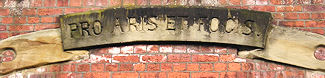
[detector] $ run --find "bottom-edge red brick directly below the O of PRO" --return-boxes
[83,72,111,78]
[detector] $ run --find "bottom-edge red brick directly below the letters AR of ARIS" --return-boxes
[112,72,139,78]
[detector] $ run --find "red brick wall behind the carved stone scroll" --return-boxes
[0,0,325,78]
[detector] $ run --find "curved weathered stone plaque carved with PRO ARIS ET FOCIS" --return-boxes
[60,7,271,49]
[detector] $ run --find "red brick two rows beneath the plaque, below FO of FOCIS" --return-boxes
[192,54,219,62]
